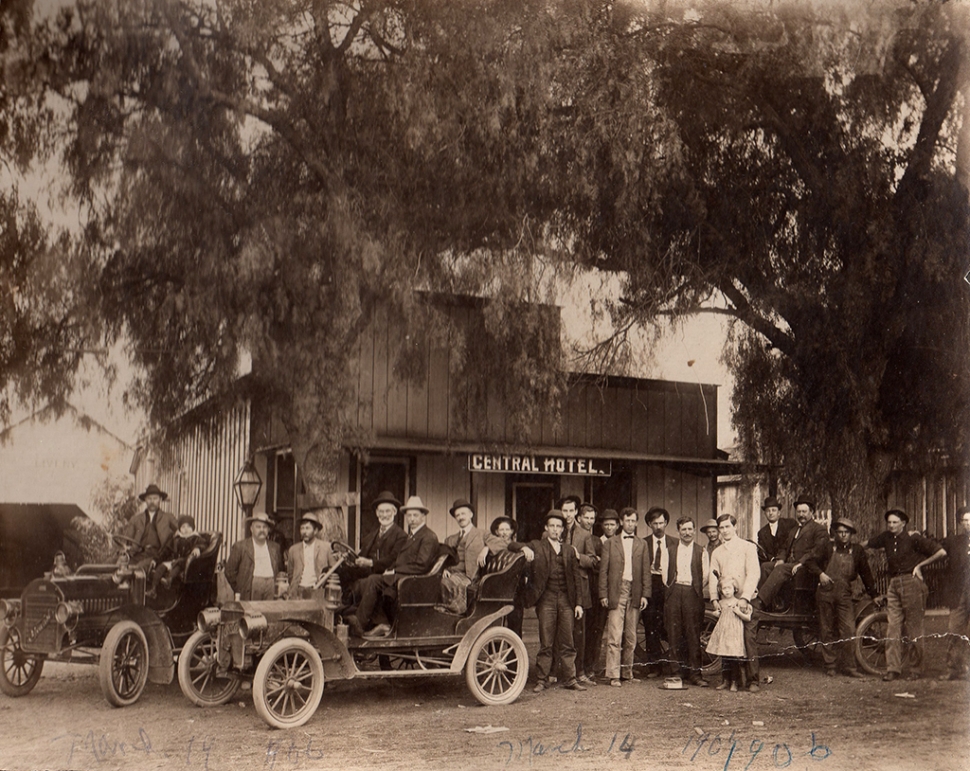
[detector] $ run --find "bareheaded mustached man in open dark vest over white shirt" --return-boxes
[664,517,711,687]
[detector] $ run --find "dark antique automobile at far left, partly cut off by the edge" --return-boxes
[0,533,225,707]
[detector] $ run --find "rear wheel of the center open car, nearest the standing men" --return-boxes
[465,626,529,706]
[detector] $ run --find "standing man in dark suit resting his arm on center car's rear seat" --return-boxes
[509,509,586,693]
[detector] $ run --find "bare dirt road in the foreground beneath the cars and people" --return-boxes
[0,619,970,771]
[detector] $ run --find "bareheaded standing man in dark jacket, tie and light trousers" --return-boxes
[599,507,651,688]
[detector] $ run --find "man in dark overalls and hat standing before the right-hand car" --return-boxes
[815,517,879,677]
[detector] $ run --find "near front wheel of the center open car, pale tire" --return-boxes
[253,637,323,728]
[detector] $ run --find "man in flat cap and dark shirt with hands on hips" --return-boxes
[866,509,946,681]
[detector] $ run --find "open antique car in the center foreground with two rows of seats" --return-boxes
[178,543,529,728]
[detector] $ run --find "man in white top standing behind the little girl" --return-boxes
[708,514,761,693]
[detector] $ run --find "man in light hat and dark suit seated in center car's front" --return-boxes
[347,495,438,637]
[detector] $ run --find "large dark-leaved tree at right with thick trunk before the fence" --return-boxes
[552,3,970,520]
